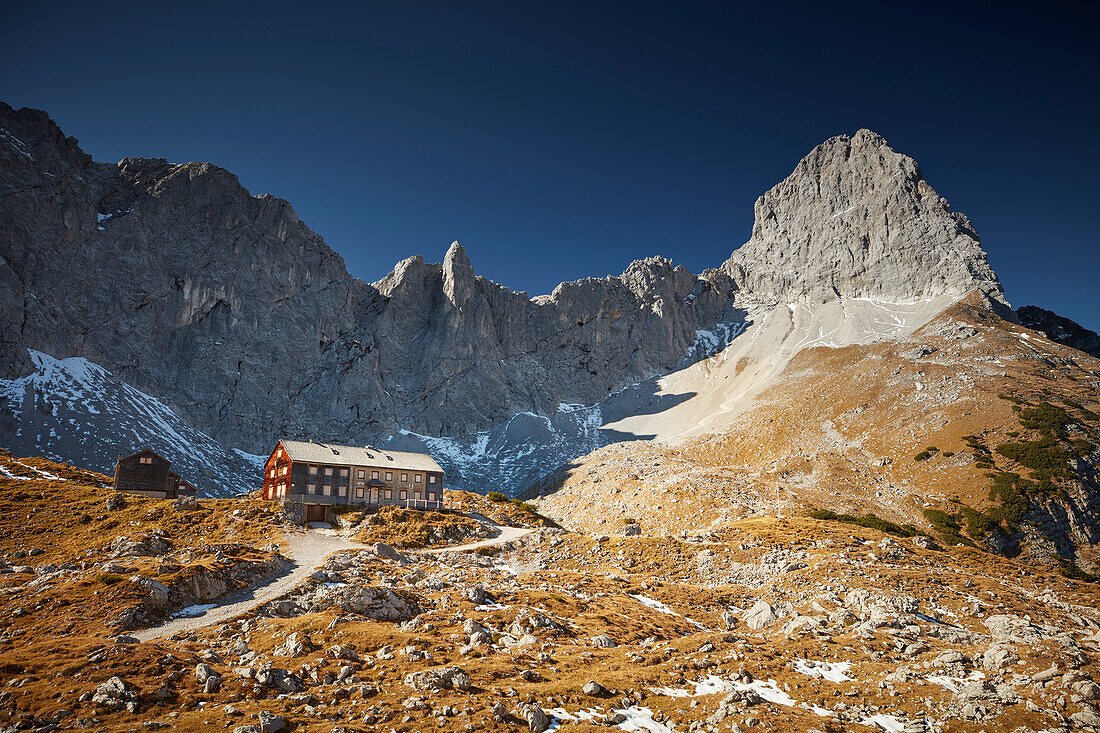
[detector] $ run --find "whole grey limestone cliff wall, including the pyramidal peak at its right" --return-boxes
[0,103,1000,462]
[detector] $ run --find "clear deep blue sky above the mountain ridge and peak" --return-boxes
[0,0,1100,330]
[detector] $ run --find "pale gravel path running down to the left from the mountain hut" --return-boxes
[130,529,363,642]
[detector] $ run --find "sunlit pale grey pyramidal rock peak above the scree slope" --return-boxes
[724,130,1003,303]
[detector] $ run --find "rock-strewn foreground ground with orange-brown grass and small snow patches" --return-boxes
[0,449,1100,733]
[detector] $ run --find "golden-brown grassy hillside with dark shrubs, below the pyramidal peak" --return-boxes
[531,293,1100,573]
